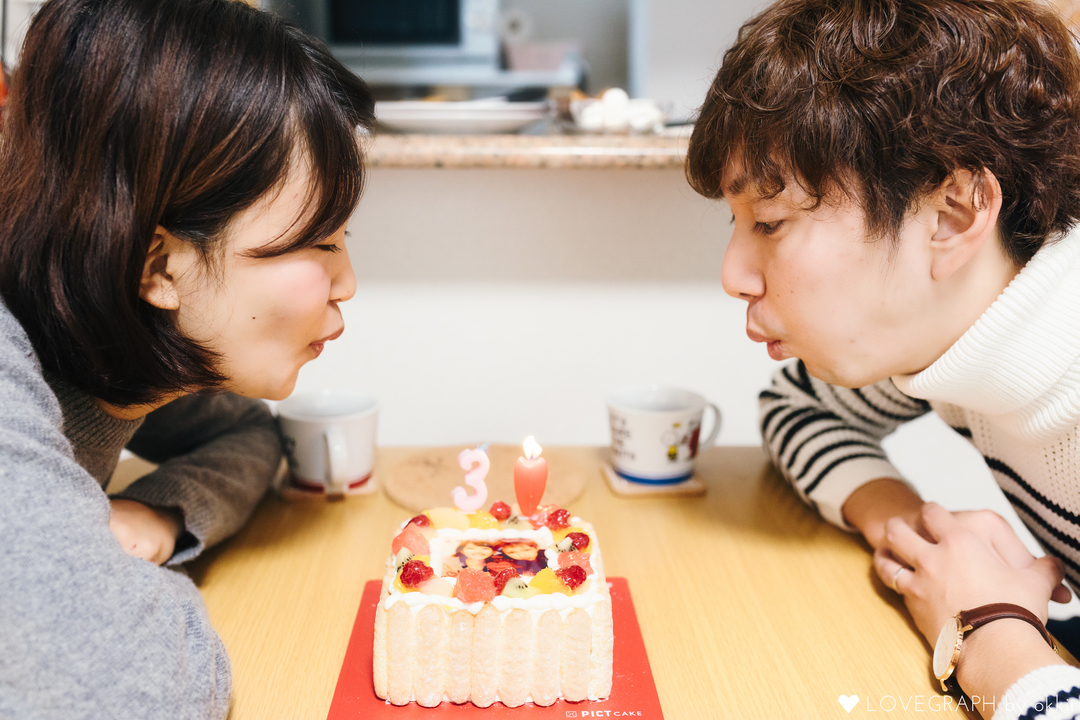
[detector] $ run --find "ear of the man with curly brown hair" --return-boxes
[930,168,1001,281]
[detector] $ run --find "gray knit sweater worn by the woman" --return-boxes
[0,304,281,720]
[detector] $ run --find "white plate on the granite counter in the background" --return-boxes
[375,100,548,135]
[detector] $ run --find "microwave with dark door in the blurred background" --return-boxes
[319,0,499,68]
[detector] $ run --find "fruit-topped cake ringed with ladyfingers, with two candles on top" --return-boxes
[374,437,612,707]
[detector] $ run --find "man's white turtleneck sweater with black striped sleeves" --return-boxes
[760,230,1080,720]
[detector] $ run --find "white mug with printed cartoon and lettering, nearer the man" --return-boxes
[608,385,720,485]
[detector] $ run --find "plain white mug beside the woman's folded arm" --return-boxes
[278,389,379,494]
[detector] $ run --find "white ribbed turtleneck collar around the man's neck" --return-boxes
[893,229,1080,439]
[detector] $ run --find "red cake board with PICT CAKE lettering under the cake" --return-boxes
[326,578,664,720]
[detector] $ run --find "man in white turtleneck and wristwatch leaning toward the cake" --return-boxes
[687,0,1080,718]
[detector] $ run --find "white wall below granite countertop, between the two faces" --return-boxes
[291,169,743,445]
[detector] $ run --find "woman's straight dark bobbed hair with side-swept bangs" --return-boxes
[0,0,374,405]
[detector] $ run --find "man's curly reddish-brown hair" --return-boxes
[686,0,1080,264]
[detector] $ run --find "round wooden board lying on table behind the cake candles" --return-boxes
[383,445,596,513]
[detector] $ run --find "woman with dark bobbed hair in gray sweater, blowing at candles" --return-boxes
[0,0,374,719]
